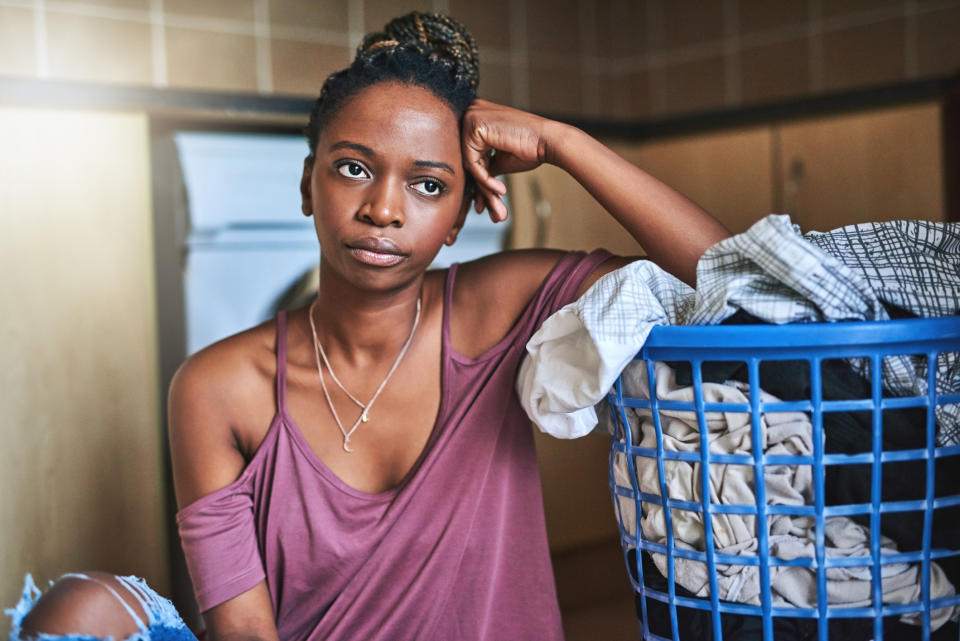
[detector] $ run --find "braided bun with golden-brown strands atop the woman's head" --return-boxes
[357,11,480,92]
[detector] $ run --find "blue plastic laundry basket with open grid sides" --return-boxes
[608,317,960,641]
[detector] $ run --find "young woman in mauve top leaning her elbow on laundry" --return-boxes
[11,13,727,641]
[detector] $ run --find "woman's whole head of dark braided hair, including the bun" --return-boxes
[304,11,480,160]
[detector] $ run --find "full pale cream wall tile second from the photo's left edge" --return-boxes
[47,11,153,84]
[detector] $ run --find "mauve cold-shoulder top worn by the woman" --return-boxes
[177,251,609,641]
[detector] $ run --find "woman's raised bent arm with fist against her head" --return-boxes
[462,100,730,285]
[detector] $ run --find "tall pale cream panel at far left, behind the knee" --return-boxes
[0,107,169,636]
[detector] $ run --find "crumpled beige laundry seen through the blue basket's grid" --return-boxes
[614,362,960,629]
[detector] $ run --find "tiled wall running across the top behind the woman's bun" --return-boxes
[0,0,960,120]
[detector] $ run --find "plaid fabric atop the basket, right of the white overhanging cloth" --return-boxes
[683,215,960,445]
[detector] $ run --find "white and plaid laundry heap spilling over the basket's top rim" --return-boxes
[517,215,960,446]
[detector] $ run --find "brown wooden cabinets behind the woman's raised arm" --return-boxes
[510,102,948,254]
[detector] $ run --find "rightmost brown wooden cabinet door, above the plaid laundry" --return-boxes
[777,104,944,231]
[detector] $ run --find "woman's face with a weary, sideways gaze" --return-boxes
[301,82,470,289]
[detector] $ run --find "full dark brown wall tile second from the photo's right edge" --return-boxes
[823,18,905,91]
